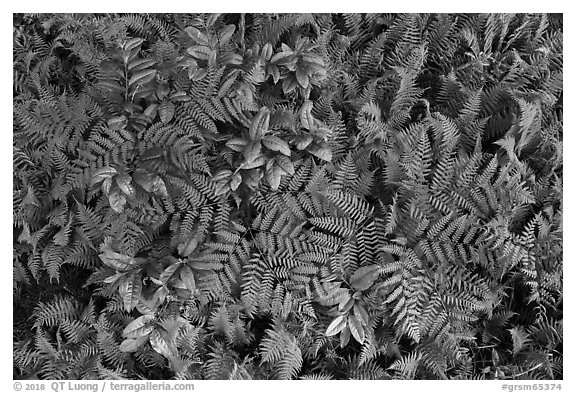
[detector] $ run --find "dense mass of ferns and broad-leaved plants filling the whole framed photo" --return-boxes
[13,14,563,379]
